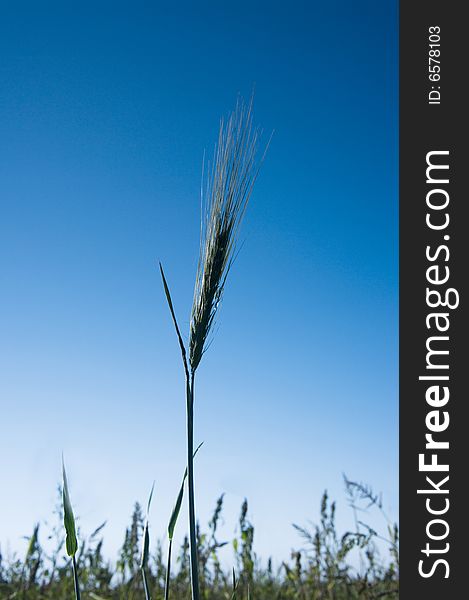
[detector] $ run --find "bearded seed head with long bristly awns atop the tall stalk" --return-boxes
[189,100,261,373]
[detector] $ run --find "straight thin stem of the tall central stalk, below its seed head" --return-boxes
[186,373,199,600]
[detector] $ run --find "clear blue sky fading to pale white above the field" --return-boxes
[0,0,398,558]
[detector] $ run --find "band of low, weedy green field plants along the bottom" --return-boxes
[0,479,399,600]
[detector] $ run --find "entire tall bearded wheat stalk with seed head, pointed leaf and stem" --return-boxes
[160,98,265,600]
